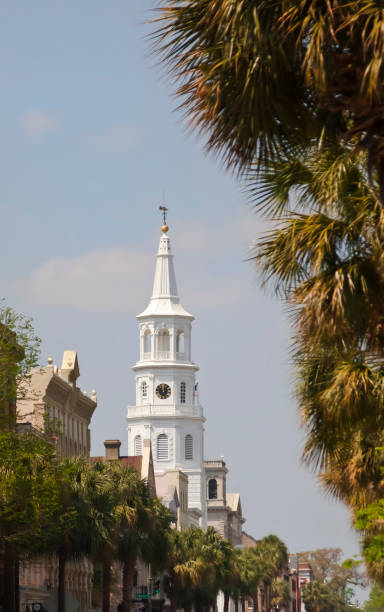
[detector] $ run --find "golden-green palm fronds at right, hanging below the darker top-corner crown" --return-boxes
[252,146,384,504]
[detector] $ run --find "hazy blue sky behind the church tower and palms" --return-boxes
[0,0,364,584]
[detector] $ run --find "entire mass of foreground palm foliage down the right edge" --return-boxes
[153,0,384,584]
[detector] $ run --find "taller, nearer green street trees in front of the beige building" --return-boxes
[0,432,172,612]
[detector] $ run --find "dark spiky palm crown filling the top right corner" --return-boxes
[153,0,384,196]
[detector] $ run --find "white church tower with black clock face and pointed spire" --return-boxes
[127,219,207,527]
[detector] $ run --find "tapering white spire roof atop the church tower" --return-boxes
[137,233,194,319]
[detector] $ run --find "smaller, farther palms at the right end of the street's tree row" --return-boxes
[165,527,290,612]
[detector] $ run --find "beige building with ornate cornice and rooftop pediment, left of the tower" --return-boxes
[17,351,97,612]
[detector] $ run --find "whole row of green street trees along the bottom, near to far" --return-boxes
[0,432,289,612]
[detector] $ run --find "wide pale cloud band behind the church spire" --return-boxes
[14,216,264,316]
